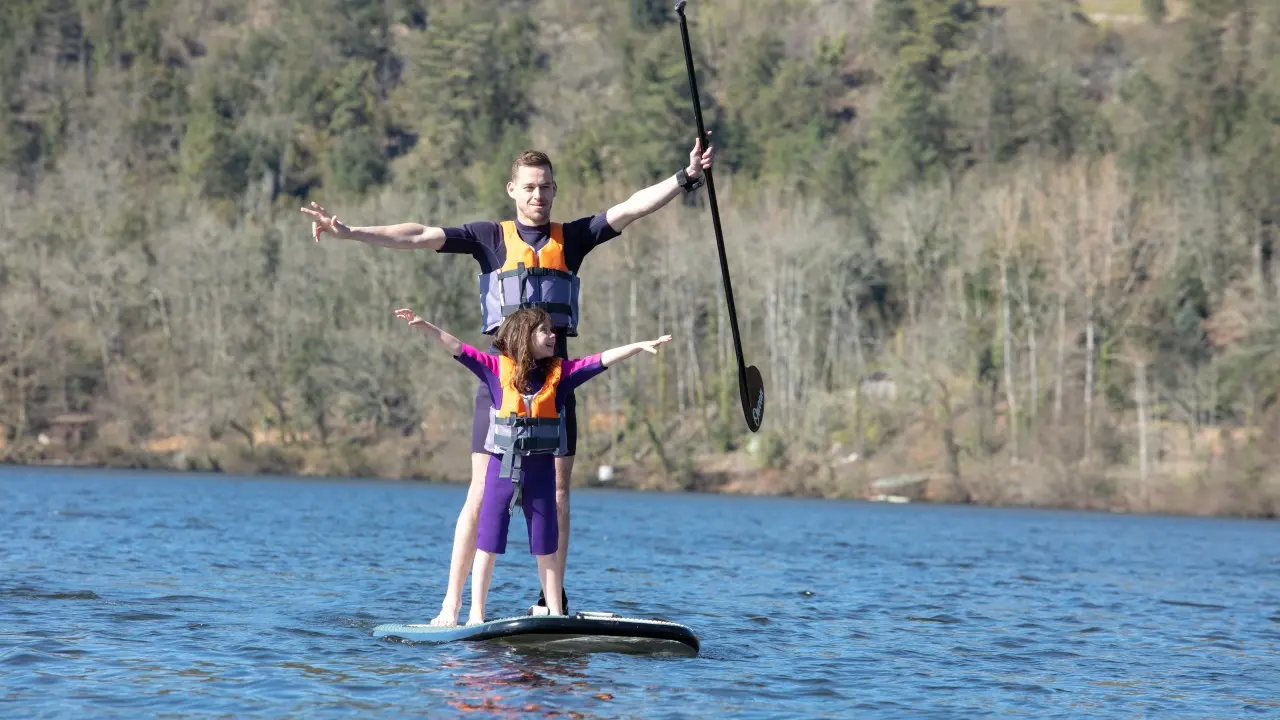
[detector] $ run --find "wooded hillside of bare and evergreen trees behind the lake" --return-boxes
[0,0,1280,515]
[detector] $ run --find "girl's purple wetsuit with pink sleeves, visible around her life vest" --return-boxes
[456,342,605,555]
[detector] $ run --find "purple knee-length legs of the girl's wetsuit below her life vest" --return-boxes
[476,455,559,555]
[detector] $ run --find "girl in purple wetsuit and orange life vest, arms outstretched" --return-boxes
[396,302,671,625]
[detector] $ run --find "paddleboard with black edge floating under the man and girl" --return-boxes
[374,611,699,655]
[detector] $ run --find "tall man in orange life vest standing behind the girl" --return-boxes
[302,134,714,625]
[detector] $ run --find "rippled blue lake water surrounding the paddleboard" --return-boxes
[0,468,1280,719]
